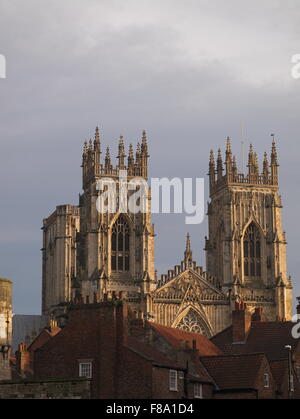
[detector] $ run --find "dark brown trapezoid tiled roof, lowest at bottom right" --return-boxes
[200,354,265,390]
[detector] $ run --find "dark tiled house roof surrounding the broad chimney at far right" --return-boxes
[211,322,299,361]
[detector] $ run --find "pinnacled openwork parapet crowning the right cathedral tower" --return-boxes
[208,137,279,195]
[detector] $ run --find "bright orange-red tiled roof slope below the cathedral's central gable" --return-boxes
[150,323,223,356]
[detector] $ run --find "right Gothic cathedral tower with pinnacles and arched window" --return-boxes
[205,138,292,320]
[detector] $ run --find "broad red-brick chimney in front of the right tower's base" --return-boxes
[232,302,251,343]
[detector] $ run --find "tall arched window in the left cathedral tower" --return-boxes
[111,215,130,272]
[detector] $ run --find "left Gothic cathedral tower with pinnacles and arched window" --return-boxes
[73,128,155,316]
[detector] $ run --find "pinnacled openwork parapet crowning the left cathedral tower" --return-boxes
[82,127,149,189]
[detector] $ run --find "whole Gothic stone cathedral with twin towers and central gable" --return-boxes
[42,128,292,338]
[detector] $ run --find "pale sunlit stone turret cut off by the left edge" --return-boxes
[0,278,12,380]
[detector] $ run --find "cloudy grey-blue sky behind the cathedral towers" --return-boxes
[0,0,300,314]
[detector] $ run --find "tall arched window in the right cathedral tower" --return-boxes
[244,223,261,278]
